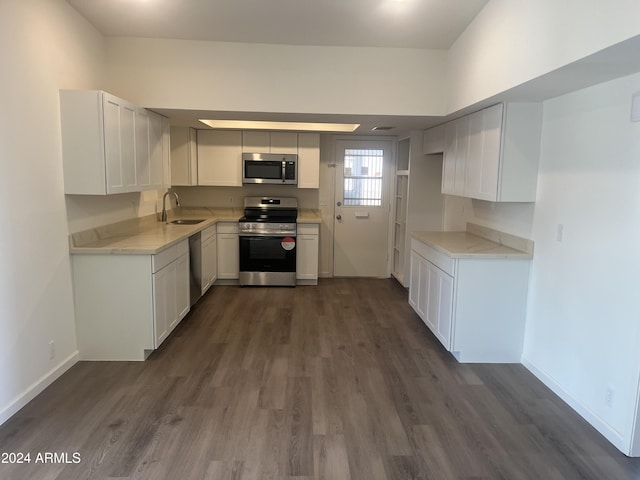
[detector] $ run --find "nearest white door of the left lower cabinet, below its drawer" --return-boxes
[153,262,177,348]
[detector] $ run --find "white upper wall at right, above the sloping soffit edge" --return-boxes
[447,0,640,112]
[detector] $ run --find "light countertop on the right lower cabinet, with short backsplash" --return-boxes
[412,223,533,259]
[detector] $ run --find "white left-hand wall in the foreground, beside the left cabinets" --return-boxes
[0,0,103,422]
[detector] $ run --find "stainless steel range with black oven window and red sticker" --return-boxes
[238,197,298,286]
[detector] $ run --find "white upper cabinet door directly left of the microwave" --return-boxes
[198,130,242,187]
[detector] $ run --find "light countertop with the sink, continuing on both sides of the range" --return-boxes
[69,208,321,255]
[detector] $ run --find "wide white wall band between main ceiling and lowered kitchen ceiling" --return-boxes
[107,38,446,115]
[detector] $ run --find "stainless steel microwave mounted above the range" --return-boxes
[242,153,298,185]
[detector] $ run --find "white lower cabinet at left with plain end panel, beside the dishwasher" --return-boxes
[71,240,190,360]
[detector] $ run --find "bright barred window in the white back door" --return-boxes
[343,148,384,206]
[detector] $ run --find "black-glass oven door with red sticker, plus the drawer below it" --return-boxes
[240,235,297,285]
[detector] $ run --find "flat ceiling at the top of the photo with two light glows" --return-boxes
[67,0,488,49]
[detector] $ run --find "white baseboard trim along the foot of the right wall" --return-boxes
[522,355,631,456]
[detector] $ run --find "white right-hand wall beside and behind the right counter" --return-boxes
[445,74,640,455]
